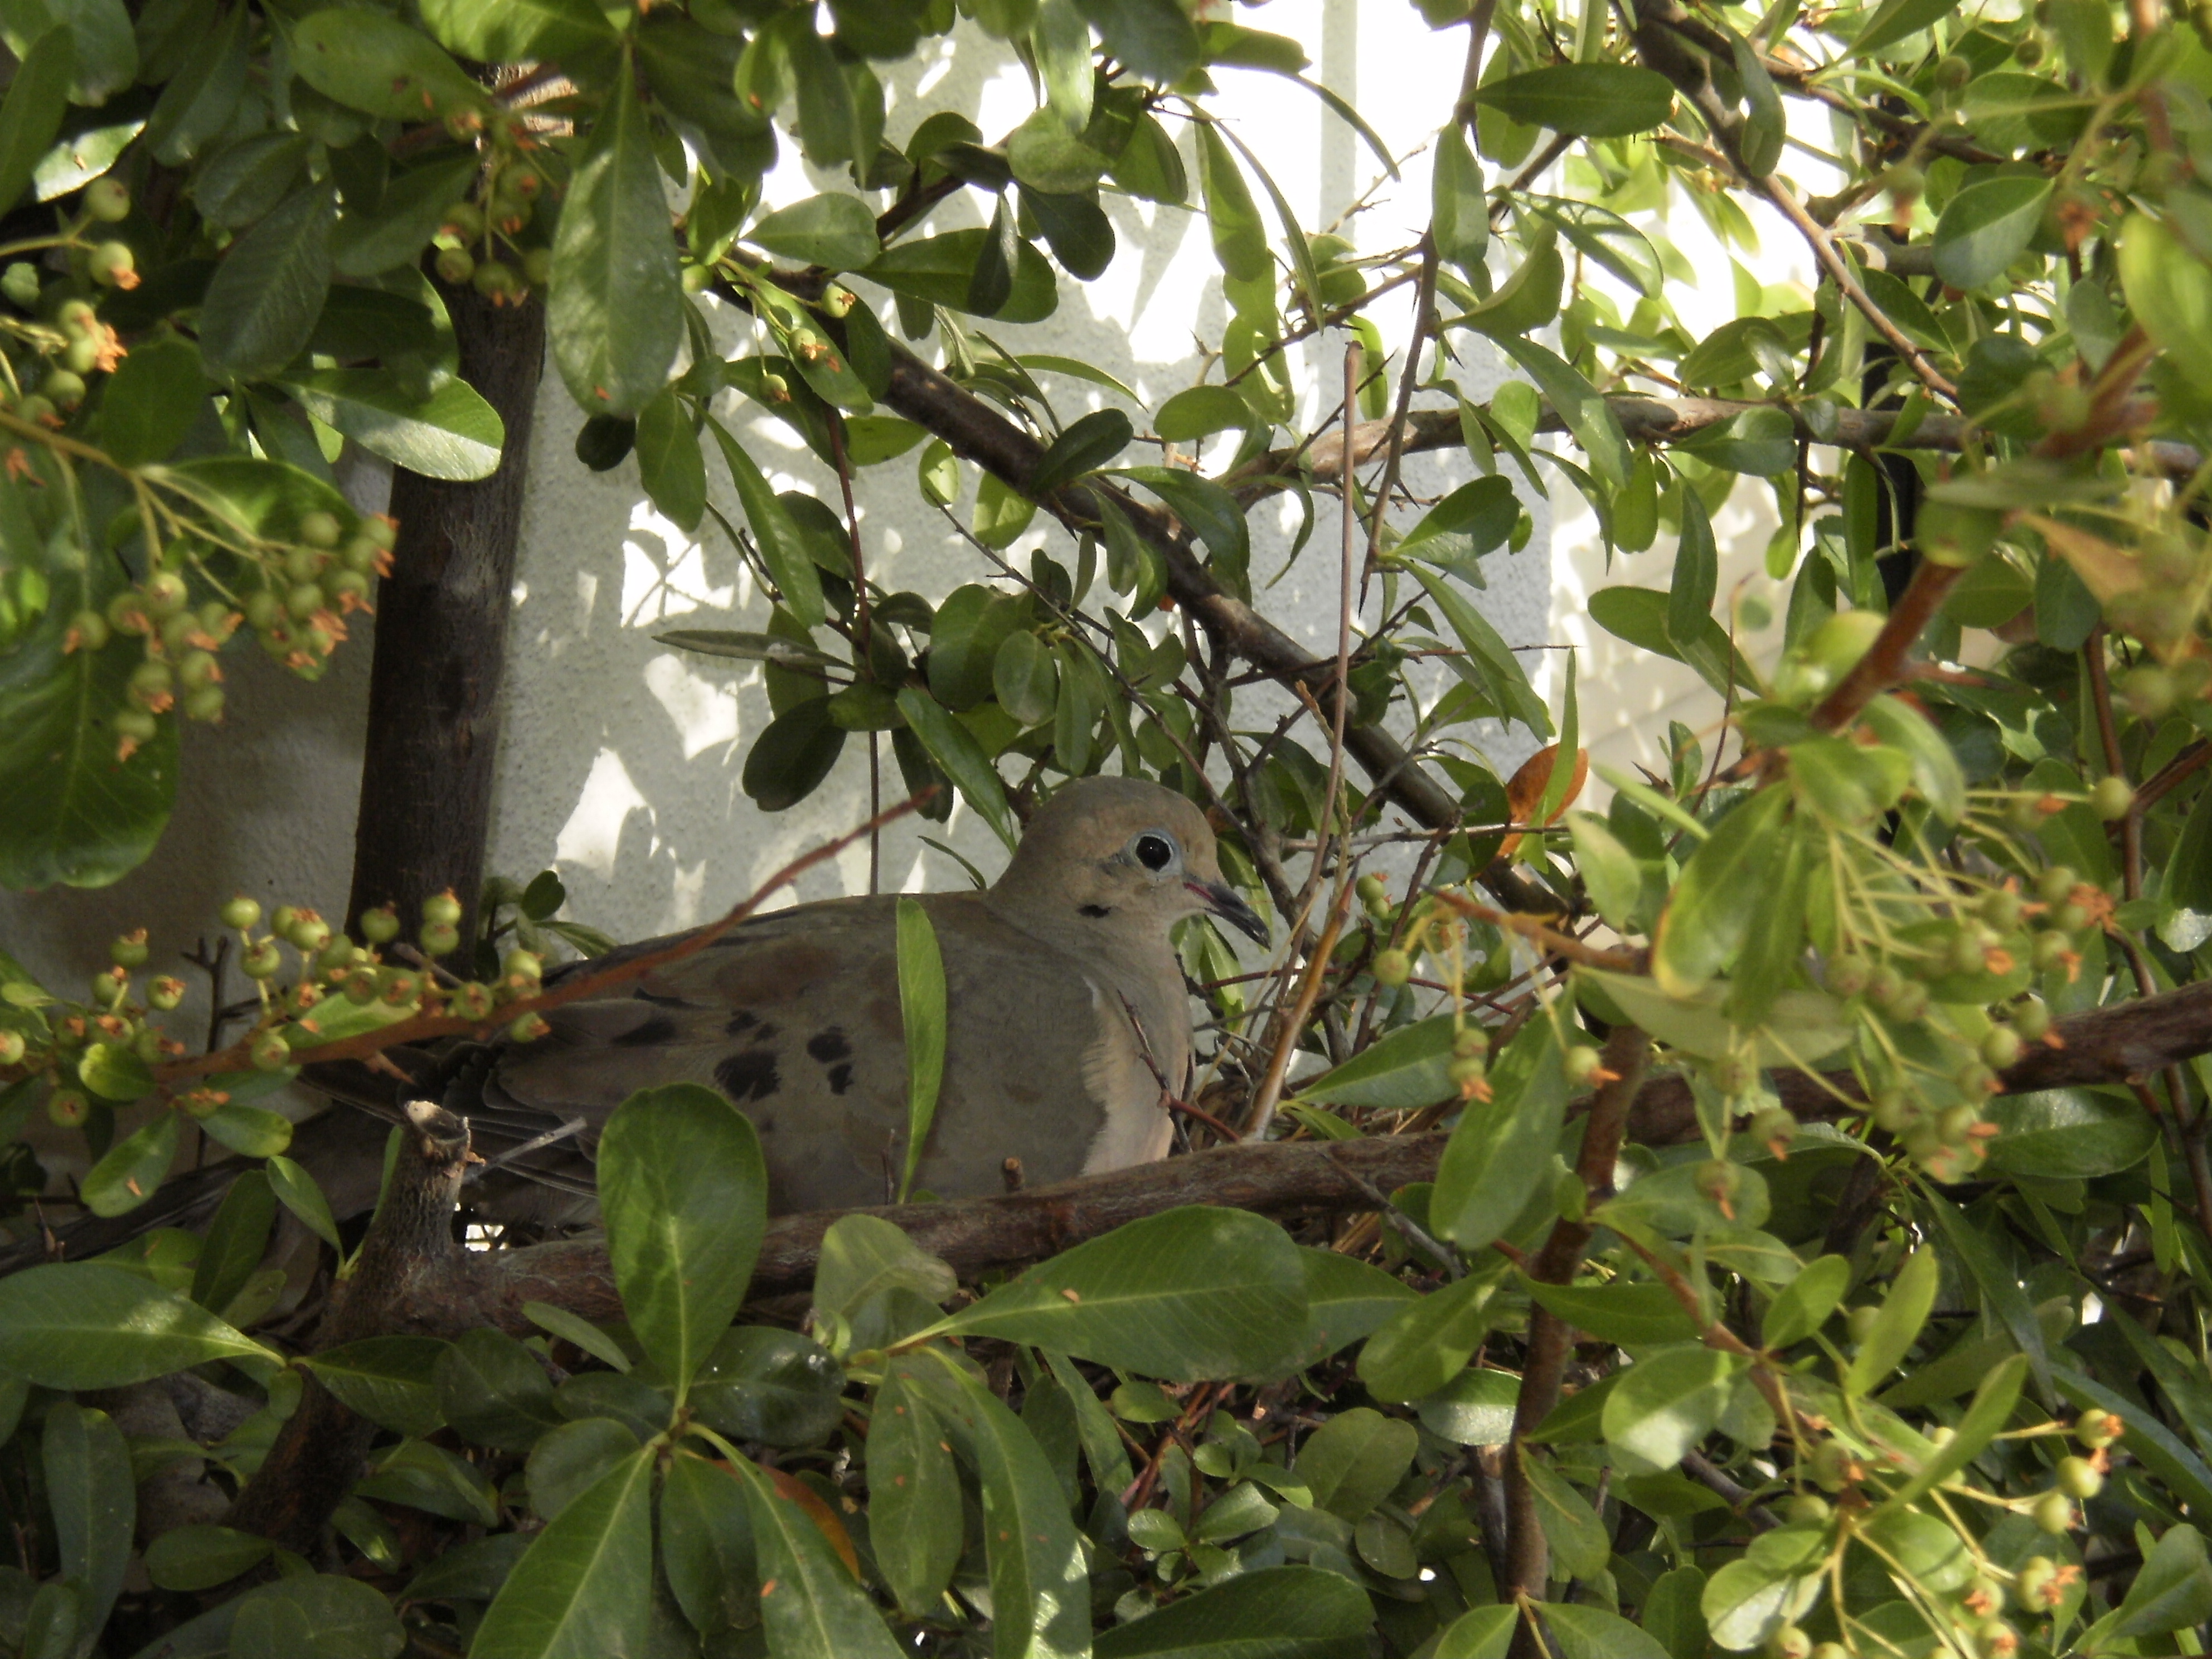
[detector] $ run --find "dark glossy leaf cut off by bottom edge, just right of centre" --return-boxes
[1090,1566,1371,1659]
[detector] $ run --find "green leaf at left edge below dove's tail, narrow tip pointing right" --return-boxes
[0,1261,283,1391]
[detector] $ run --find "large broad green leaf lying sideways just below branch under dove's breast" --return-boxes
[944,1206,1305,1380]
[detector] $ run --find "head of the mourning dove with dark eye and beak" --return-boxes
[993,779,1268,944]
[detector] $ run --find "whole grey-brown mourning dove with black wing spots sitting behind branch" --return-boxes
[447,779,1268,1221]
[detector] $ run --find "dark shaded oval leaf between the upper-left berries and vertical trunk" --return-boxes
[199,180,334,380]
